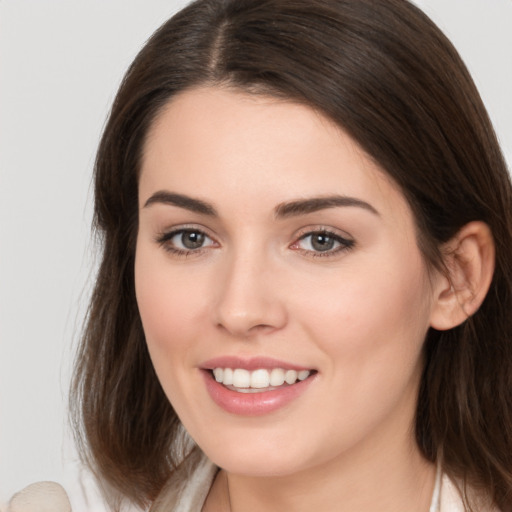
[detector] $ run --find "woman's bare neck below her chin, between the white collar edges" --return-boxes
[204,430,436,512]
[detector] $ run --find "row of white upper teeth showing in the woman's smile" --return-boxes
[213,368,311,390]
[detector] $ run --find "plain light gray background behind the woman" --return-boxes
[0,0,512,511]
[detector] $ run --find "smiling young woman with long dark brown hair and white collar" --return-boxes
[74,0,512,512]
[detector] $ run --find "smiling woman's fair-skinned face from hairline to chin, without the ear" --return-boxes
[135,88,436,475]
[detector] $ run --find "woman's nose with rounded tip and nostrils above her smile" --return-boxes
[214,249,287,338]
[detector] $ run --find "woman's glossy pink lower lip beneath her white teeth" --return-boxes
[202,370,314,416]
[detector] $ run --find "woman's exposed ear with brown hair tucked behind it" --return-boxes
[430,221,495,331]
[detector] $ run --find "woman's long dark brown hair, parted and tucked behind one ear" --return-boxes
[72,0,512,512]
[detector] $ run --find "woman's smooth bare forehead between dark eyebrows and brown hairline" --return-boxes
[139,87,408,226]
